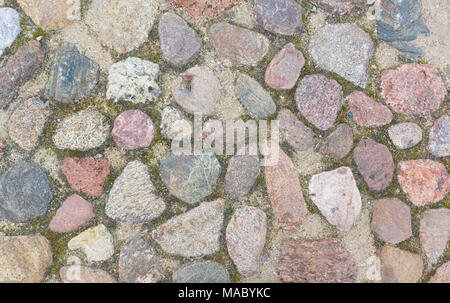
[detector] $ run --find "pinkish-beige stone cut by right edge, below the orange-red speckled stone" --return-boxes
[419,208,450,264]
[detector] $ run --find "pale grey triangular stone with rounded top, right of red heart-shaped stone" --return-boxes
[105,160,166,224]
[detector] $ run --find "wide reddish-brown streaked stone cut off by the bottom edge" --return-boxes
[277,238,357,283]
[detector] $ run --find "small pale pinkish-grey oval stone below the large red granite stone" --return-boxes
[388,122,422,149]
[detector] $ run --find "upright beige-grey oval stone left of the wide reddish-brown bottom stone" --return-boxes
[226,206,267,277]
